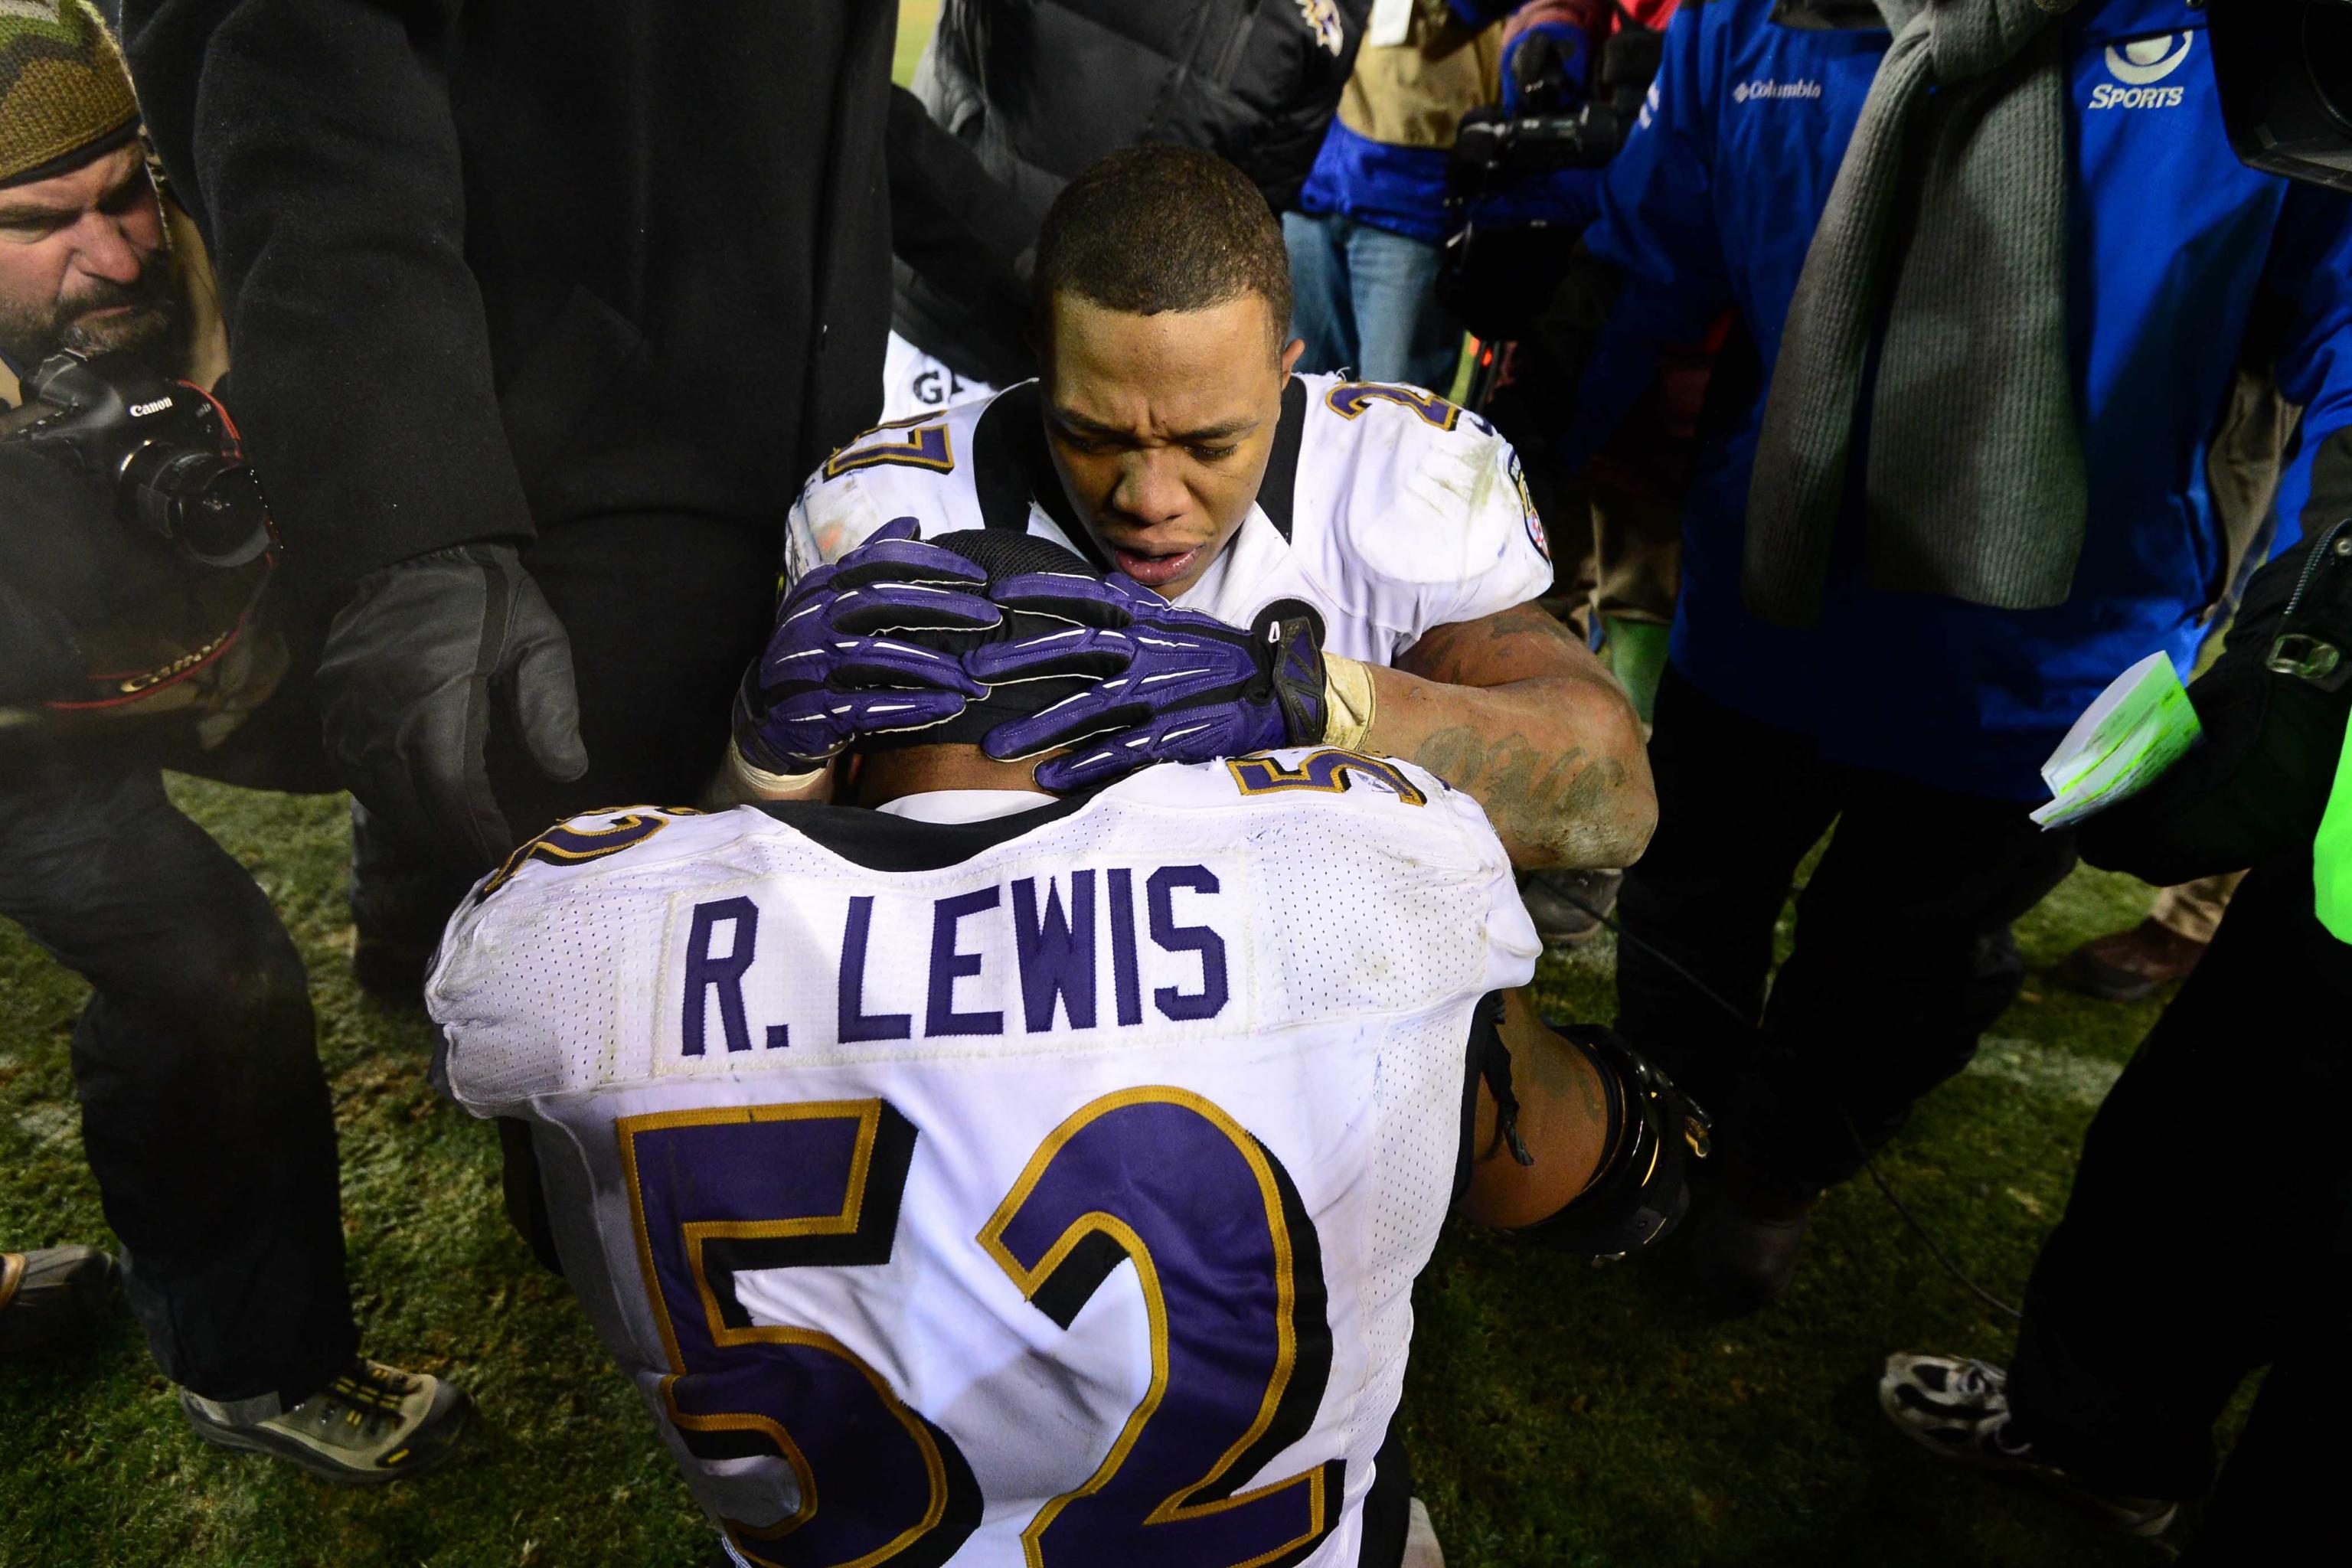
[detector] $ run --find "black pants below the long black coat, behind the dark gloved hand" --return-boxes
[351,514,781,947]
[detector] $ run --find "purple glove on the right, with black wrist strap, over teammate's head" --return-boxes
[965,571,1325,790]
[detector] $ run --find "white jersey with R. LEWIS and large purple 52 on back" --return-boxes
[428,747,1538,1568]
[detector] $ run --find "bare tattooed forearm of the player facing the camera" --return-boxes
[1364,604,1658,870]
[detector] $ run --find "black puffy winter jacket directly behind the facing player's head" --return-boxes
[891,0,1371,386]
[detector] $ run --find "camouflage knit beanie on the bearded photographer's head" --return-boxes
[0,0,139,186]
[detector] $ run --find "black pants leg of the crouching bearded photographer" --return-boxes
[0,740,358,1413]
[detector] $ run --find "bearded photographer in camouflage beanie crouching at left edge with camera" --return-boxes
[0,0,466,1481]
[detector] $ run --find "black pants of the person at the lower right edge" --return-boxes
[2008,854,2352,1563]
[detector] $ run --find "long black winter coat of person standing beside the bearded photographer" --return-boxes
[122,0,899,602]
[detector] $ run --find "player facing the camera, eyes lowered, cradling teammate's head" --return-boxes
[733,145,1656,870]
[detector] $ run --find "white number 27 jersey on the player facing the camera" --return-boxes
[786,376,1553,665]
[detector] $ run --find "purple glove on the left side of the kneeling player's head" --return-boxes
[733,518,1004,773]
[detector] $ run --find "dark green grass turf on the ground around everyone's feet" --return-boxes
[0,780,2201,1568]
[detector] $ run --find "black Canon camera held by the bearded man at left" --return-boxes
[0,350,277,567]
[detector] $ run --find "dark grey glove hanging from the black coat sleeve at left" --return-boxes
[318,545,588,867]
